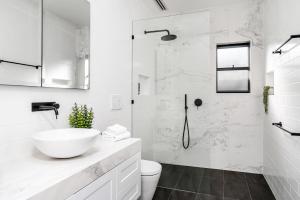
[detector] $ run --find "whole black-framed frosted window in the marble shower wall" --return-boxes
[217,42,250,93]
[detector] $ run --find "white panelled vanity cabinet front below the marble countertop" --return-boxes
[67,153,141,200]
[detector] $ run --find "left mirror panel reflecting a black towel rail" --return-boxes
[0,0,42,87]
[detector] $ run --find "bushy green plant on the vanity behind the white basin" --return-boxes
[69,103,94,128]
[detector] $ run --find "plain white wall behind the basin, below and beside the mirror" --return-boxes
[0,0,158,166]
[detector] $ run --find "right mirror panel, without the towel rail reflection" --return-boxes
[42,0,90,89]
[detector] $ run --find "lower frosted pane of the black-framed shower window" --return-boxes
[218,70,249,92]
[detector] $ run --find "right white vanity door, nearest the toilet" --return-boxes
[116,153,141,200]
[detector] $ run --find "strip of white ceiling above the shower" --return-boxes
[155,0,249,12]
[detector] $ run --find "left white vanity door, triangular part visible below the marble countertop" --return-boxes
[68,169,117,200]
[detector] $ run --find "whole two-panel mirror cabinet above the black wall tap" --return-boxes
[0,0,90,89]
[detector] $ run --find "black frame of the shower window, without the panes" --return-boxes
[216,42,251,93]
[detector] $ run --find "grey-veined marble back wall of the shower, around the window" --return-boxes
[133,1,264,172]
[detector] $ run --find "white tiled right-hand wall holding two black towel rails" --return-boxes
[264,0,300,200]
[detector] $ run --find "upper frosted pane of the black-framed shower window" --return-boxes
[218,47,249,68]
